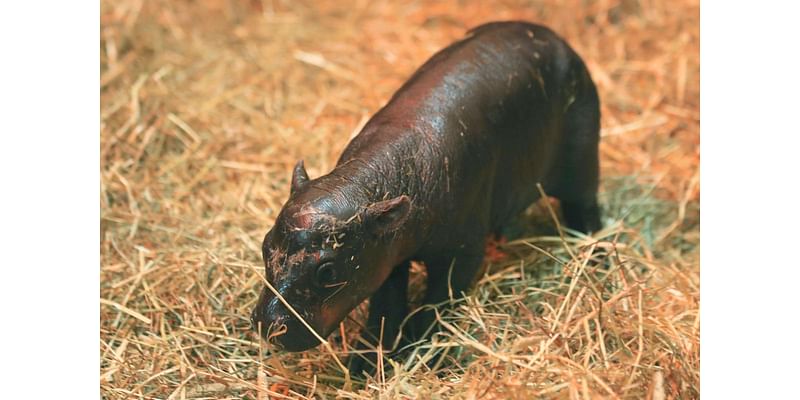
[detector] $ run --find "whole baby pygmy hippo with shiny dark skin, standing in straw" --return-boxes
[252,22,600,372]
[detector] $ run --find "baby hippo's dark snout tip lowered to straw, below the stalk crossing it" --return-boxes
[250,289,319,352]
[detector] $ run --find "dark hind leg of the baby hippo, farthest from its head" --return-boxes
[552,72,602,233]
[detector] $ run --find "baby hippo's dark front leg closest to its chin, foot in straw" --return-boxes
[349,261,411,376]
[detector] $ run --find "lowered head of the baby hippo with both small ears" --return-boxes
[251,161,411,351]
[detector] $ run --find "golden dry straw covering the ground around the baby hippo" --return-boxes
[99,0,700,399]
